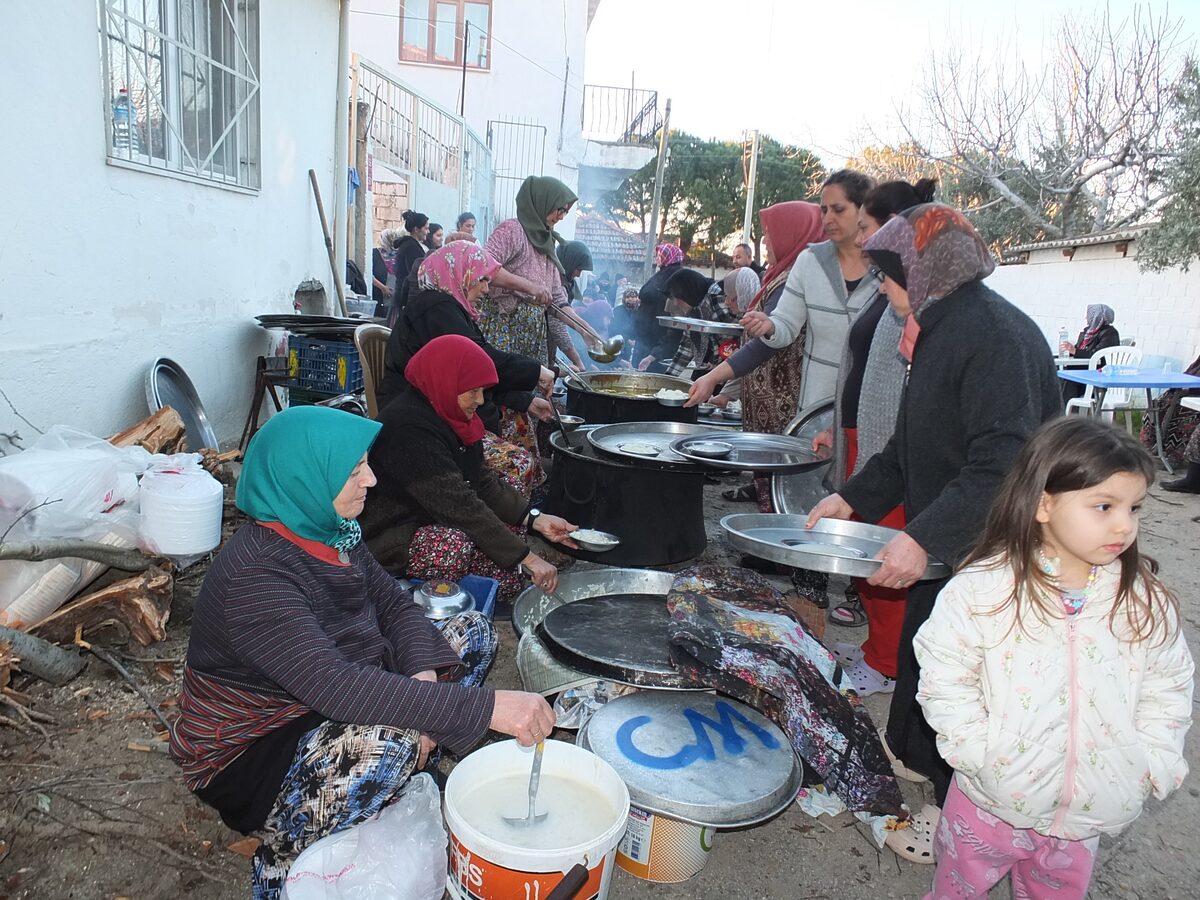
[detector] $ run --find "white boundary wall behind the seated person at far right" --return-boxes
[988,241,1200,366]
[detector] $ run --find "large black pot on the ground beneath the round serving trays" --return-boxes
[544,428,708,565]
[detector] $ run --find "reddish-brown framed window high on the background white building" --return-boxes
[400,0,492,68]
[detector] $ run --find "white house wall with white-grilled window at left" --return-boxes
[0,0,346,446]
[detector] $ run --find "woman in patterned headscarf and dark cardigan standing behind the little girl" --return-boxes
[808,203,1062,863]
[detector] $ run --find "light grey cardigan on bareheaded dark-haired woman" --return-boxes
[763,241,880,409]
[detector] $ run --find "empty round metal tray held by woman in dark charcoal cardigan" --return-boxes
[721,512,950,581]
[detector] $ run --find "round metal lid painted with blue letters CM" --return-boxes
[577,691,803,828]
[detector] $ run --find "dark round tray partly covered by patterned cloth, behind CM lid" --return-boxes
[534,595,708,690]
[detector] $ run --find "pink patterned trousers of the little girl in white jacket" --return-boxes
[925,780,1099,900]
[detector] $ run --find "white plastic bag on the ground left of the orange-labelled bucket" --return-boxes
[282,773,446,900]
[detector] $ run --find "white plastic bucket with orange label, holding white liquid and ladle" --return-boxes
[445,740,629,900]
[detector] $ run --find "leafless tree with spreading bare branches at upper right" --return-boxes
[901,7,1186,238]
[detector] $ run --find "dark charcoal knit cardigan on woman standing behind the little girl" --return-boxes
[839,281,1062,565]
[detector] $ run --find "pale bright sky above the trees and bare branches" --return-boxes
[584,0,1200,166]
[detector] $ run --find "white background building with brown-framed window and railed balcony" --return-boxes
[350,0,660,236]
